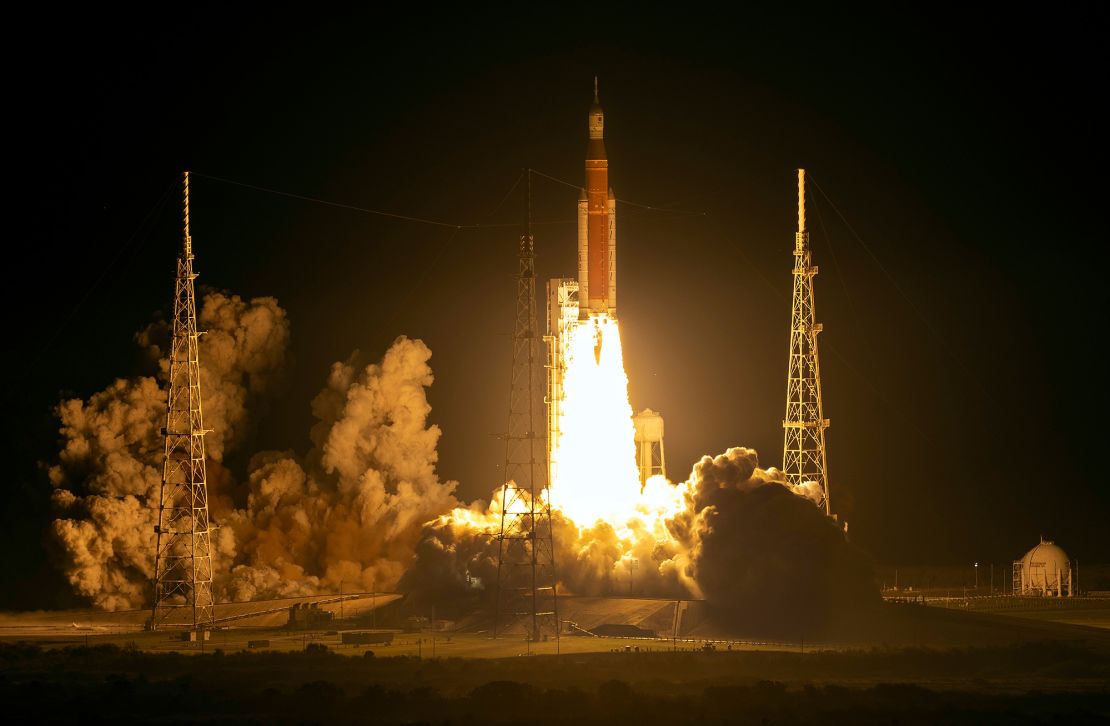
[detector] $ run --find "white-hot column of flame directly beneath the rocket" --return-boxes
[552,315,680,538]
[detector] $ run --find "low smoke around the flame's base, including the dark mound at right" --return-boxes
[401,447,876,635]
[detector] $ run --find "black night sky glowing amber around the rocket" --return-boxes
[0,4,1110,606]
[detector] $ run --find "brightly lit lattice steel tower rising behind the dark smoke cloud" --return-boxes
[783,169,829,514]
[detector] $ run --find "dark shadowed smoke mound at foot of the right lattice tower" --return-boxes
[669,447,877,636]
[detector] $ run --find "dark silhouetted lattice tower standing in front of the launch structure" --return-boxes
[494,170,559,641]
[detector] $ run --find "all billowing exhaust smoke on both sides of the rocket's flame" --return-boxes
[48,284,876,634]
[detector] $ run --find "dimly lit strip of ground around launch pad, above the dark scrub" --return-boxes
[8,596,1110,658]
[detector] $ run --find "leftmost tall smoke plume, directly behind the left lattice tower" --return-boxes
[48,292,289,609]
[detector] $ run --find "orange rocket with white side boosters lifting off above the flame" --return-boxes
[578,77,617,320]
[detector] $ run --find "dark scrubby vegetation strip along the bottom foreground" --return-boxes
[0,636,1110,725]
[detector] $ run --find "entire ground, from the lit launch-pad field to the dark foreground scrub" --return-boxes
[0,595,1110,724]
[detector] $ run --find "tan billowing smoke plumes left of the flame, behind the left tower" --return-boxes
[48,292,457,609]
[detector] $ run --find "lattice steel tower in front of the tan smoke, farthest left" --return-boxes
[150,171,213,637]
